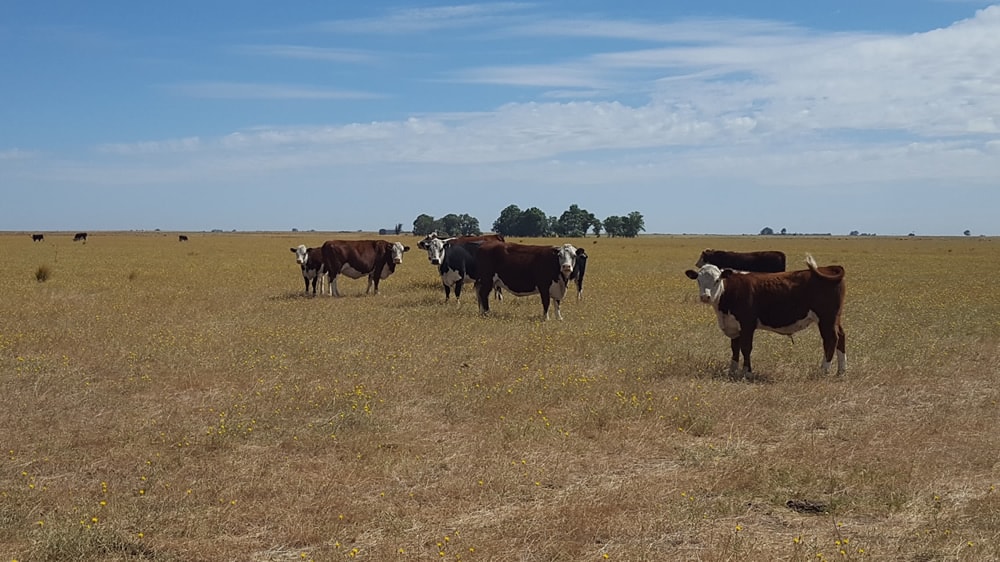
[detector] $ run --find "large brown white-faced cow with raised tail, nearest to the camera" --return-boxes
[684,255,847,378]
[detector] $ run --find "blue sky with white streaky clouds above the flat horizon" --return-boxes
[0,0,1000,235]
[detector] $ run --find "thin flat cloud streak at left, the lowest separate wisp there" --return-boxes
[166,82,385,100]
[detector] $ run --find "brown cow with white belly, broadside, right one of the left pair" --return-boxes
[322,240,410,297]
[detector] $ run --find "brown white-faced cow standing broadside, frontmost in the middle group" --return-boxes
[477,242,586,320]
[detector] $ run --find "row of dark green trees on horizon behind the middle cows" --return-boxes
[413,203,646,238]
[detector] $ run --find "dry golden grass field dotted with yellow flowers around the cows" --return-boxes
[0,232,1000,562]
